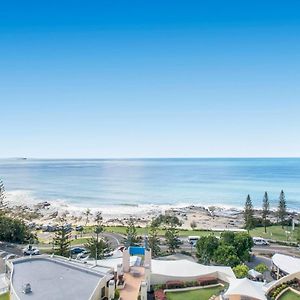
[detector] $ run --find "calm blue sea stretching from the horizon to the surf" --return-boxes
[0,158,300,211]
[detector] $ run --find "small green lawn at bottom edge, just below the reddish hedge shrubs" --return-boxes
[167,286,223,300]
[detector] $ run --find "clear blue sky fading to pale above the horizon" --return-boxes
[0,1,300,157]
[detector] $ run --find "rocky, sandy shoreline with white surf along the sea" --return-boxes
[7,192,299,230]
